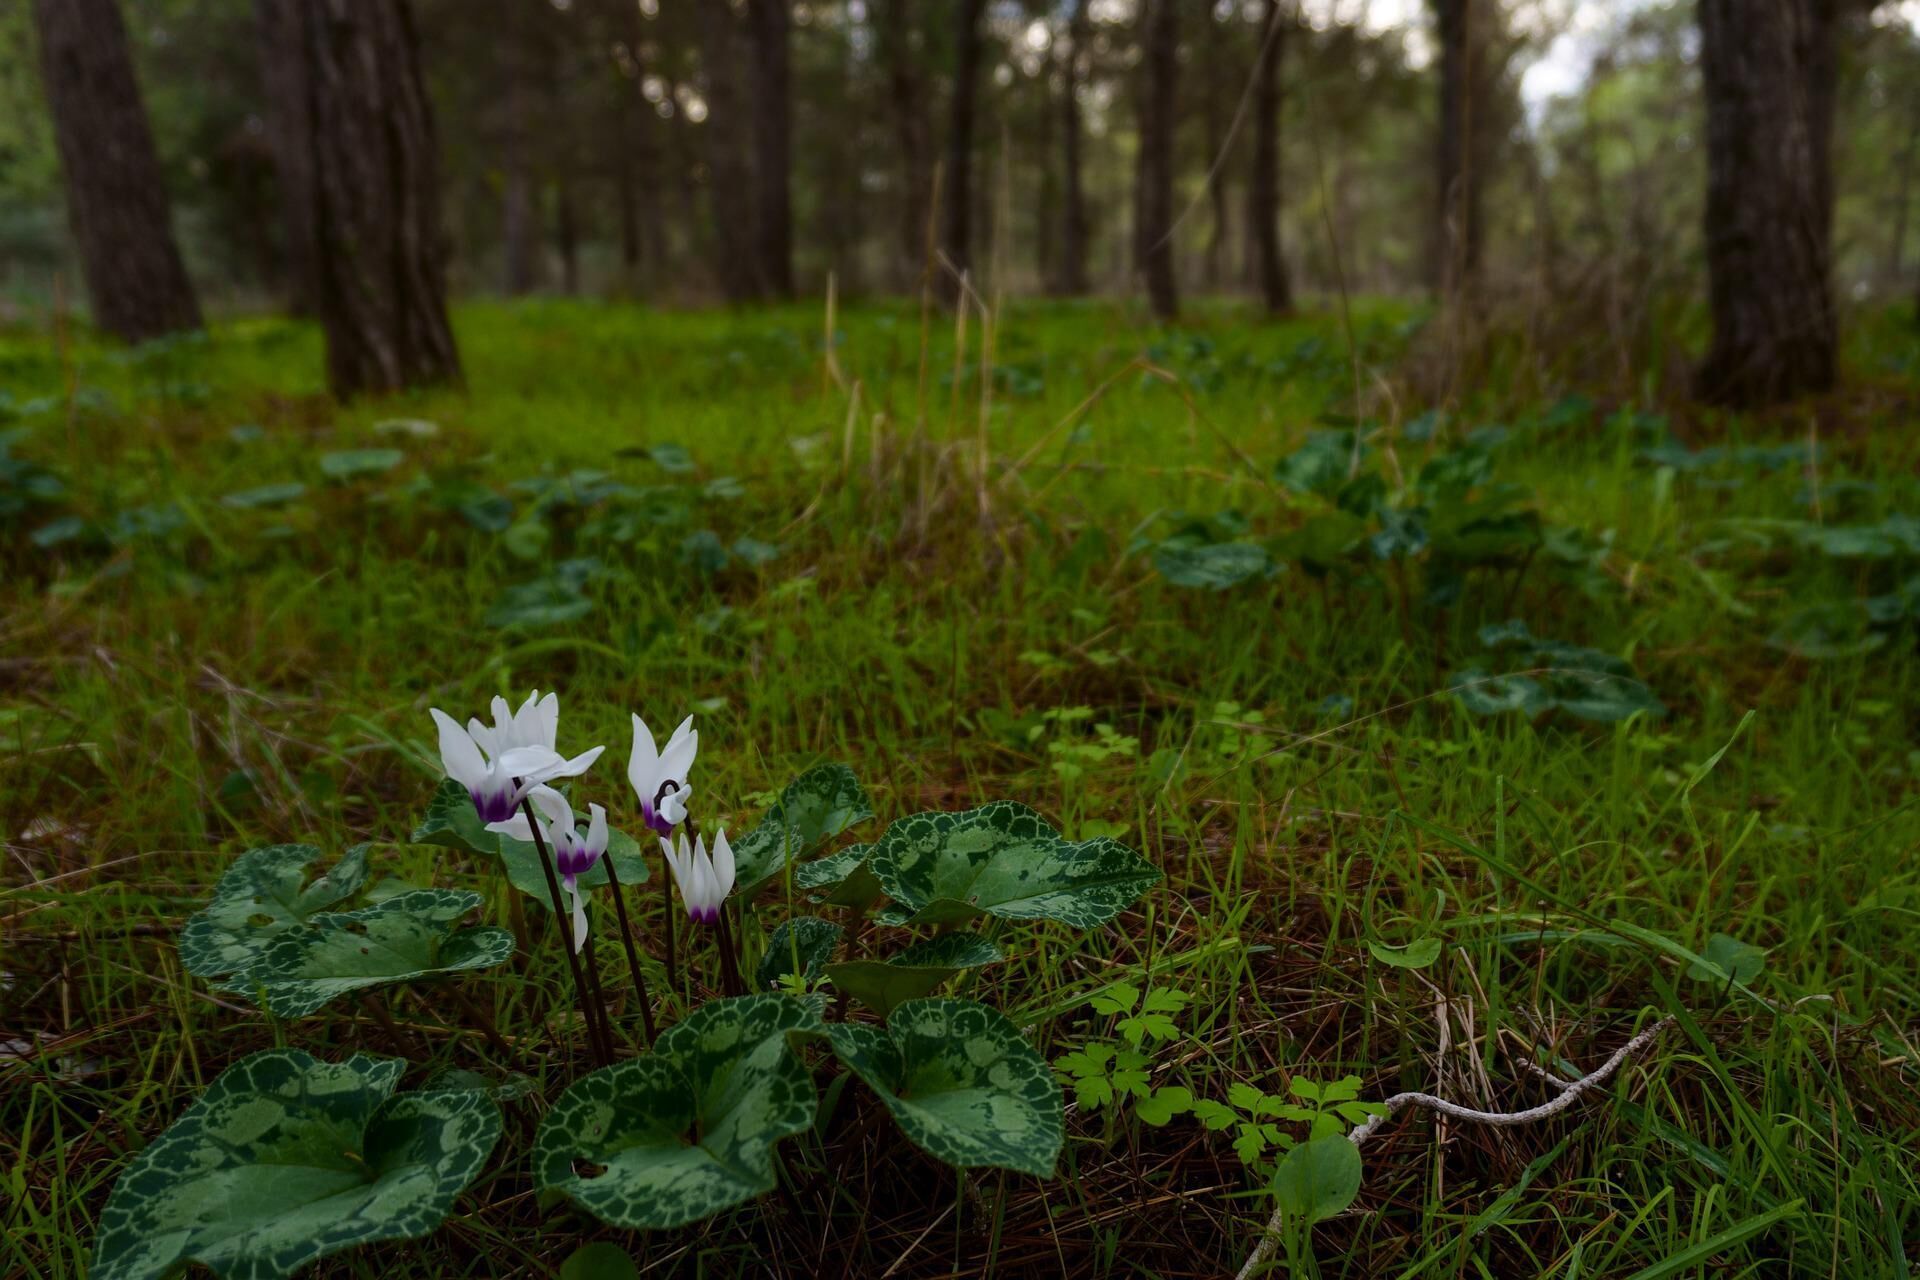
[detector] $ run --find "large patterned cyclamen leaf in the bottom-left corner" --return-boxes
[92,1050,501,1280]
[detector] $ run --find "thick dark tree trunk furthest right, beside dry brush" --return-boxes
[1695,0,1837,405]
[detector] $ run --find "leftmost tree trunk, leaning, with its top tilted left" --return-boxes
[33,0,200,342]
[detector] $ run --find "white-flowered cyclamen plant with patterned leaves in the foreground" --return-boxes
[92,693,1160,1280]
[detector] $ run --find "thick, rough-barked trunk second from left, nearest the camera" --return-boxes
[300,0,461,399]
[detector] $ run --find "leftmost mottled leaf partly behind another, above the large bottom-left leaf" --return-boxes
[180,840,372,979]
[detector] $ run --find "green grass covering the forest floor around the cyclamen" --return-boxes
[0,301,1920,1278]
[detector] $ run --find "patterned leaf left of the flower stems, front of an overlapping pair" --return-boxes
[221,889,513,1017]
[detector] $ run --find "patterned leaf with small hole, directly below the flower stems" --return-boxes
[534,994,822,1230]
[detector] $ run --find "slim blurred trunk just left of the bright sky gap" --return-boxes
[1432,0,1494,299]
